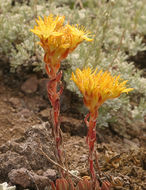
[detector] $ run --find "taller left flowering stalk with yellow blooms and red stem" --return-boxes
[31,15,92,176]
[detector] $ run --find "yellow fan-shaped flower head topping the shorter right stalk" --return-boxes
[71,67,133,112]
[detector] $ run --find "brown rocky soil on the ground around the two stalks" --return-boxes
[0,65,146,190]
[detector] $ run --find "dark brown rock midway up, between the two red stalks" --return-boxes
[61,116,87,137]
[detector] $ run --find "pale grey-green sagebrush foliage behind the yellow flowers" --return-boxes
[0,0,146,126]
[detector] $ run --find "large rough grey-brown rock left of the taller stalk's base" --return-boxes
[0,122,54,182]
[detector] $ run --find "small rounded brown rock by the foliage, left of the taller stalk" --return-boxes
[21,76,38,94]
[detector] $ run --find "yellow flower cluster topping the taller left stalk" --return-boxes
[31,15,92,64]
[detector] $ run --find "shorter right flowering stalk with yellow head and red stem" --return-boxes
[71,68,133,190]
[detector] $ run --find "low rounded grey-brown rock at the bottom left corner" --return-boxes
[8,168,49,189]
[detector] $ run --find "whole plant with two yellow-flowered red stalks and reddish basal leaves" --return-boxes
[31,14,133,190]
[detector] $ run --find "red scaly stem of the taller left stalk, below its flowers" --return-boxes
[46,64,64,177]
